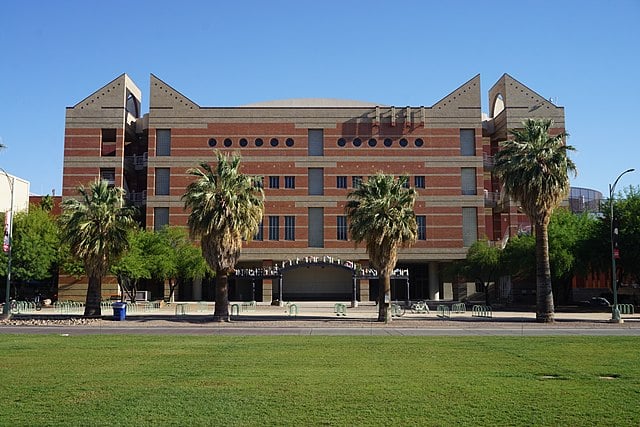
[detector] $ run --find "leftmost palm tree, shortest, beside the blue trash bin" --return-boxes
[60,180,136,316]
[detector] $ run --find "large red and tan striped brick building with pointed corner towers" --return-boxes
[59,74,564,301]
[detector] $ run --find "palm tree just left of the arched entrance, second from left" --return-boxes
[182,152,264,322]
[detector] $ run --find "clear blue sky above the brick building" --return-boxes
[0,0,640,195]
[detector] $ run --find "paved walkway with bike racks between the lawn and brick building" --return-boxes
[0,302,640,336]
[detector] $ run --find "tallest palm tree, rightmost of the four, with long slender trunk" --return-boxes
[494,119,576,322]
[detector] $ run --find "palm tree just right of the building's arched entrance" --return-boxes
[345,172,418,323]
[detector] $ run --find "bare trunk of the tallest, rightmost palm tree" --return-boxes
[535,220,554,323]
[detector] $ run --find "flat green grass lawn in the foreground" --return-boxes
[0,335,640,426]
